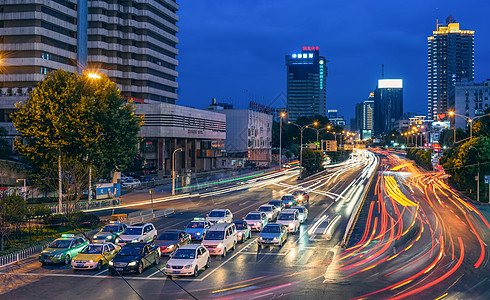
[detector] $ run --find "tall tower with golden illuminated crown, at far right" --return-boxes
[428,16,475,120]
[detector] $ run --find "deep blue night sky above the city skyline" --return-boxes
[177,0,490,123]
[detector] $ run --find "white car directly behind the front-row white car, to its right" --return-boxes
[202,223,237,257]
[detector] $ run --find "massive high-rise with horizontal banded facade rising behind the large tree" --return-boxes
[0,0,178,105]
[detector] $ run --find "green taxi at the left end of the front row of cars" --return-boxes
[39,234,89,265]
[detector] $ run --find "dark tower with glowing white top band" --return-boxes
[374,79,403,136]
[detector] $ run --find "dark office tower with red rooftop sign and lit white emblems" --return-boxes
[286,47,328,122]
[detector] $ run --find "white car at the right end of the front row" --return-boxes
[164,244,210,277]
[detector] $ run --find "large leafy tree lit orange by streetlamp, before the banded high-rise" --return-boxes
[12,70,143,210]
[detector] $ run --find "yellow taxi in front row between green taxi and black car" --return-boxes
[71,242,121,270]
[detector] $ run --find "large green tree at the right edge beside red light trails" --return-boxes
[440,136,490,202]
